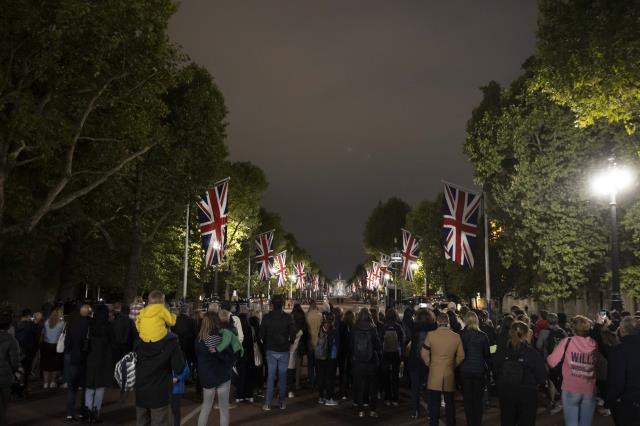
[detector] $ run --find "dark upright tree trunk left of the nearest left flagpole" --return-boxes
[124,163,143,303]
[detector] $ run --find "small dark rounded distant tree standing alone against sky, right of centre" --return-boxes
[363,197,411,258]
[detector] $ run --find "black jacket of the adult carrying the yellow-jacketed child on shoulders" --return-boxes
[135,333,185,408]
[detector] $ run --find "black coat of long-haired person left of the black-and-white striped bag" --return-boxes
[86,320,115,389]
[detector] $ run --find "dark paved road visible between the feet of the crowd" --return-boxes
[8,383,613,426]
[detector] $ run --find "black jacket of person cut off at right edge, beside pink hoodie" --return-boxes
[607,334,640,403]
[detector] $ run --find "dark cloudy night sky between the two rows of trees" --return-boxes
[170,0,536,276]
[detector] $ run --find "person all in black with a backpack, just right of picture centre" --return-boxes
[351,308,382,417]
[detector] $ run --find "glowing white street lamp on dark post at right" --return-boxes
[591,157,634,312]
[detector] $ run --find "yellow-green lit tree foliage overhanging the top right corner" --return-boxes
[533,0,640,132]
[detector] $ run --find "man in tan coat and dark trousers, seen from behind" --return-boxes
[420,313,464,426]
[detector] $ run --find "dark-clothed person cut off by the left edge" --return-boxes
[0,311,20,426]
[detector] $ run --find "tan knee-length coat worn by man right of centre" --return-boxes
[420,327,464,392]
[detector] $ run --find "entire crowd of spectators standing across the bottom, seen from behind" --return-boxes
[0,291,640,426]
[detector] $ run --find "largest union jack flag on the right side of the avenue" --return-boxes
[442,183,482,268]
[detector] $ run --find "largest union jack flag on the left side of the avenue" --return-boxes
[197,178,229,267]
